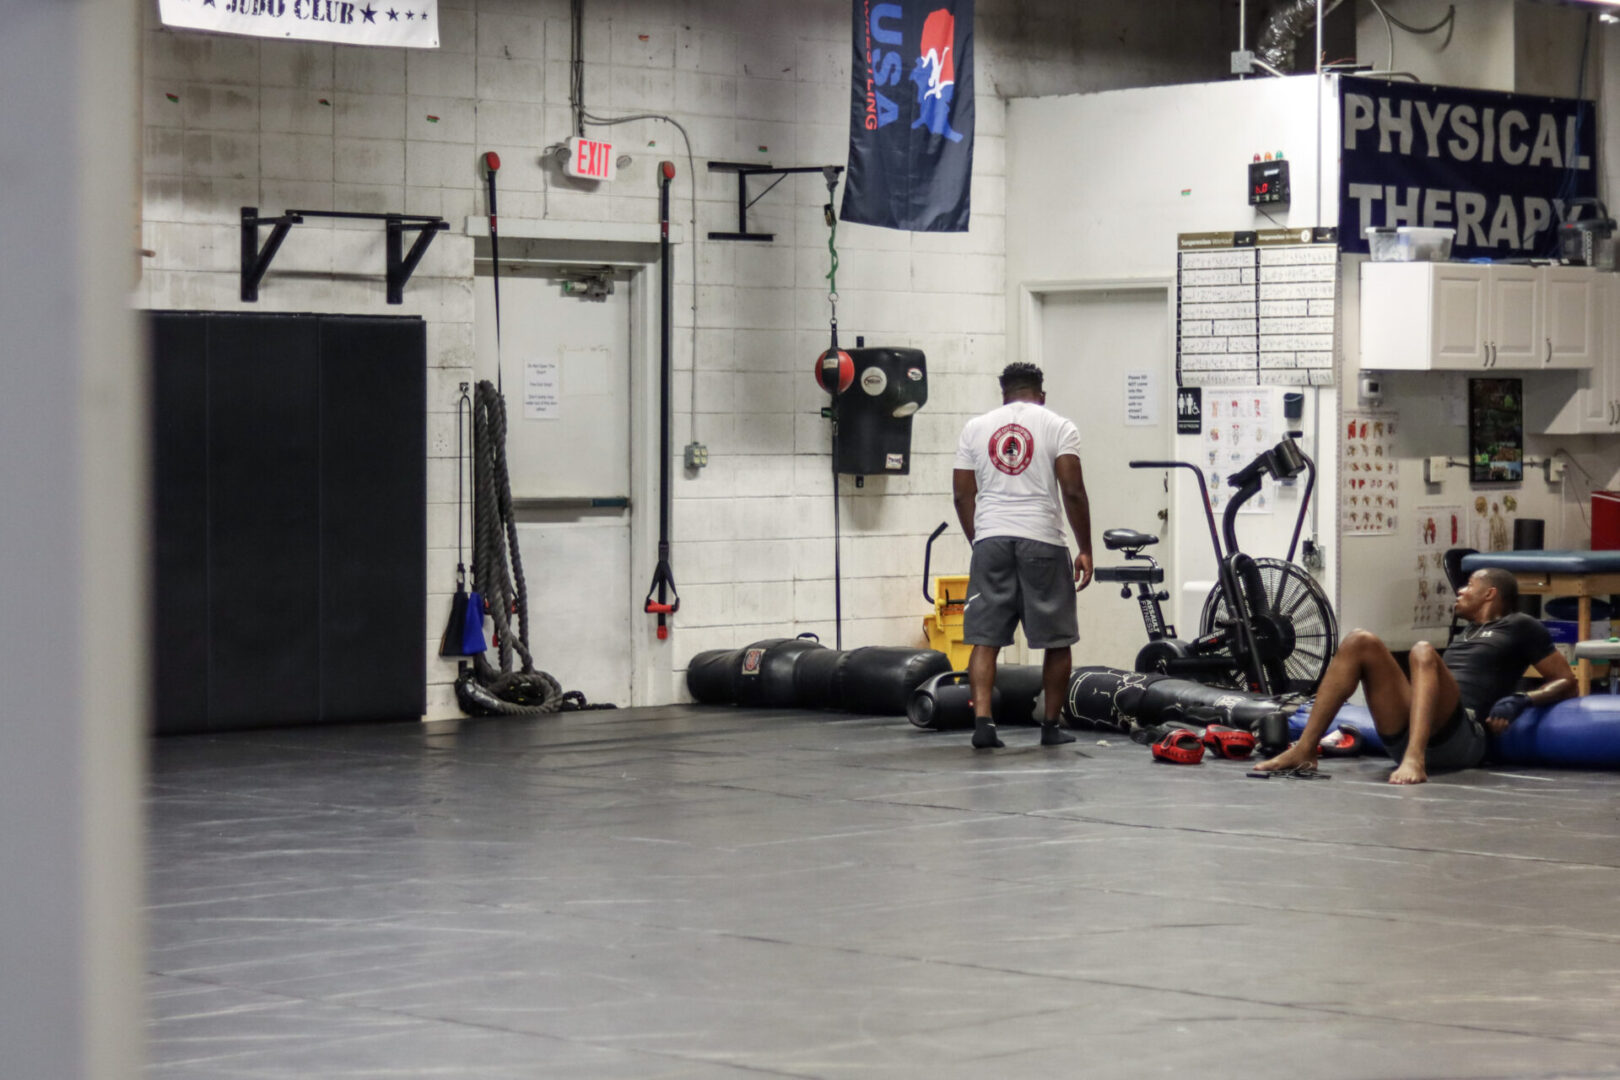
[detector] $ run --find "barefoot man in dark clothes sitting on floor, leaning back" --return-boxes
[1256,568,1576,784]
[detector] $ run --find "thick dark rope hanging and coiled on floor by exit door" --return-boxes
[455,379,614,716]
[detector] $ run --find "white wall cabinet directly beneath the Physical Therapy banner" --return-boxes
[1361,262,1602,371]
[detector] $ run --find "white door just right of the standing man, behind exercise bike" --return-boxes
[1032,288,1176,670]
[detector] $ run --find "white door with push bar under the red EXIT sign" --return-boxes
[475,261,631,706]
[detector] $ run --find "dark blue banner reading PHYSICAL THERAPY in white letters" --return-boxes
[1338,78,1597,259]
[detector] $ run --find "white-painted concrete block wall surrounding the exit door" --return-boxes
[138,0,1236,716]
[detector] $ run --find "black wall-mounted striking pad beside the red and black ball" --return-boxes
[838,348,928,476]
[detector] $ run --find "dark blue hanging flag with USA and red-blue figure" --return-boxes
[841,0,974,233]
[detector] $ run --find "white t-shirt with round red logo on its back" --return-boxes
[956,402,1081,547]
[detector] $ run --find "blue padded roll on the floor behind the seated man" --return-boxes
[1288,696,1620,769]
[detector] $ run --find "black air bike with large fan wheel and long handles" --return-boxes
[1095,437,1338,696]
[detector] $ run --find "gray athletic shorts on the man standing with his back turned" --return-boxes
[962,536,1081,649]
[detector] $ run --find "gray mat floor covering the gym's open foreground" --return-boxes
[149,708,1620,1080]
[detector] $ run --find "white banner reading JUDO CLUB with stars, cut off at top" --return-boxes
[157,0,439,49]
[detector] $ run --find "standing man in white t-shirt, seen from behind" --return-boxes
[953,363,1092,750]
